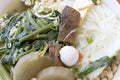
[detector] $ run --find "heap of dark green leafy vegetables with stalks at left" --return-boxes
[0,9,60,65]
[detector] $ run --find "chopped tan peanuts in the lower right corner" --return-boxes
[95,53,120,80]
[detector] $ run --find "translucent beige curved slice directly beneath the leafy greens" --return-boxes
[12,52,53,80]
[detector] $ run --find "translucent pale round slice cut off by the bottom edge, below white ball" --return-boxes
[37,67,75,80]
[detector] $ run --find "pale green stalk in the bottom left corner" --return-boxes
[0,63,12,80]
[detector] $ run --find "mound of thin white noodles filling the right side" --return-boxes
[78,4,120,80]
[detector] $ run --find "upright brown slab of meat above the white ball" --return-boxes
[57,6,80,43]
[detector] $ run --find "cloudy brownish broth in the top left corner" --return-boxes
[0,0,28,17]
